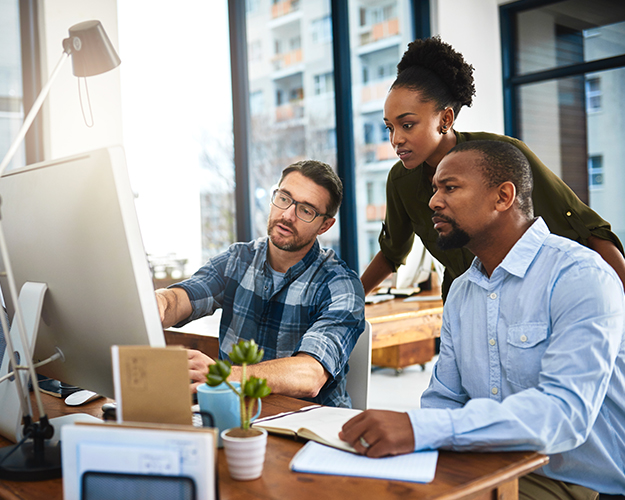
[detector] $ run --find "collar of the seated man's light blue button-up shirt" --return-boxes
[471,217,550,284]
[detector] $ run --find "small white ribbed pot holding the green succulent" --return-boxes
[221,429,267,481]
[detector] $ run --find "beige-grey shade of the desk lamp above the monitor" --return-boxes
[63,21,121,76]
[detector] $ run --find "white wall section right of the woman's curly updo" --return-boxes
[431,0,505,134]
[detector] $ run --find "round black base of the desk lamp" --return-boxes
[0,439,61,481]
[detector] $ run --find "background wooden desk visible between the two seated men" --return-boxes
[365,289,443,373]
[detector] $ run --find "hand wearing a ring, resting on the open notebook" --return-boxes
[339,410,415,458]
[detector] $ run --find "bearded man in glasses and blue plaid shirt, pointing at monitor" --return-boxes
[156,160,365,406]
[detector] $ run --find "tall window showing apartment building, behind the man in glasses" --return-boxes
[229,0,430,272]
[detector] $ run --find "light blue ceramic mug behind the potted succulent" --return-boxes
[197,382,262,448]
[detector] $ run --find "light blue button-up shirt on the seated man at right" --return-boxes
[408,218,625,494]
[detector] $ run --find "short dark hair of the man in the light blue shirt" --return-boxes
[448,141,534,219]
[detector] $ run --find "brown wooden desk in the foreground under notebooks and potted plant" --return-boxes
[0,395,548,500]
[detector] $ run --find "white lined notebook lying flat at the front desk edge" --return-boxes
[289,441,438,483]
